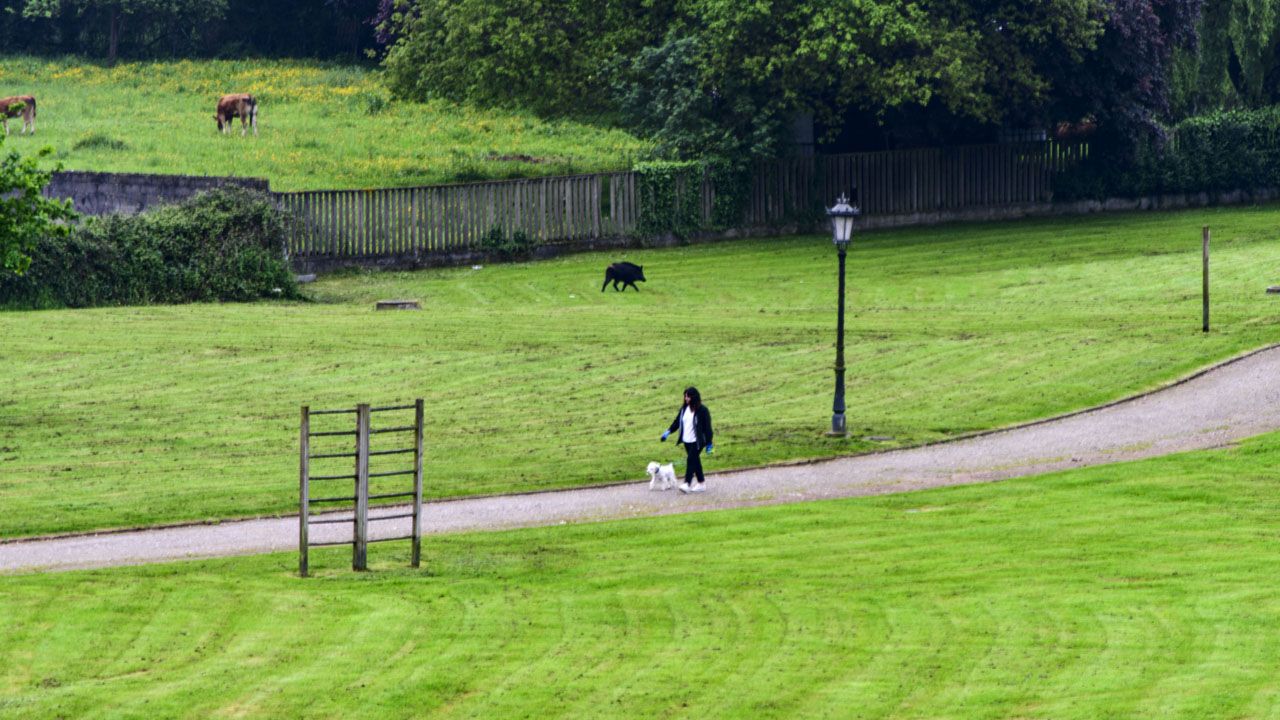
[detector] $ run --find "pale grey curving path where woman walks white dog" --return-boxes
[0,346,1280,571]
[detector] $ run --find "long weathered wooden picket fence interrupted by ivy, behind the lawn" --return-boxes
[276,142,1087,259]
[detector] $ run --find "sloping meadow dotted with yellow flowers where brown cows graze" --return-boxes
[0,56,645,191]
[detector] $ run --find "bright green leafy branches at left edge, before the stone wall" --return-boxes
[0,136,77,274]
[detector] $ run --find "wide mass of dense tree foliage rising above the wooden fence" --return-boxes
[380,0,1198,156]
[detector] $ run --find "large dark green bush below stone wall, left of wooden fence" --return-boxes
[0,188,298,307]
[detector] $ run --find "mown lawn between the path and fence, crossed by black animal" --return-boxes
[0,208,1280,536]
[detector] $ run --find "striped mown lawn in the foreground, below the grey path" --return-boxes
[0,436,1280,720]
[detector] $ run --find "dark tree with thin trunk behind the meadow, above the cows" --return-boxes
[23,0,227,64]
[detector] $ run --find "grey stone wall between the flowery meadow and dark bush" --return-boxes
[45,170,271,215]
